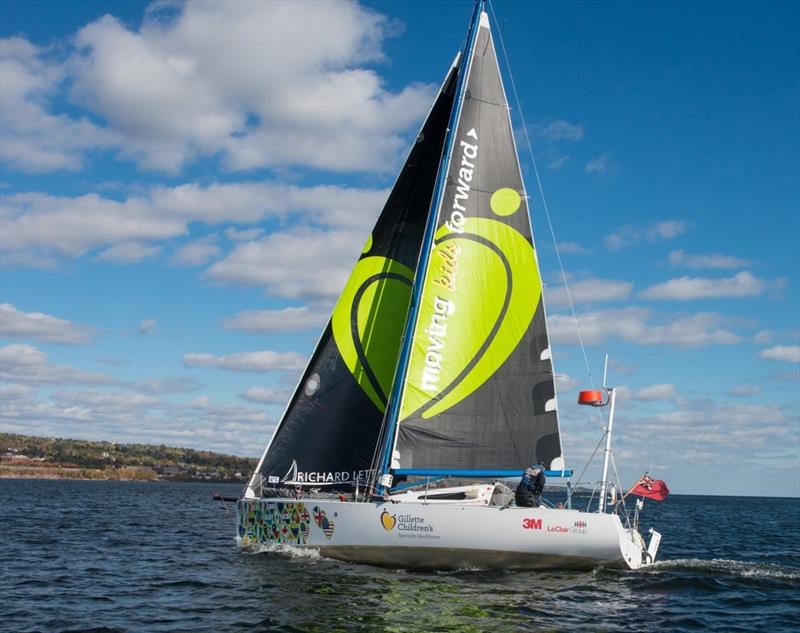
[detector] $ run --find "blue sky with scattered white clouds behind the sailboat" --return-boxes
[0,1,800,496]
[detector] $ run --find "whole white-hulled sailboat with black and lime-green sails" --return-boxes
[237,1,660,569]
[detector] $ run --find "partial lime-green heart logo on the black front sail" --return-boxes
[331,256,414,411]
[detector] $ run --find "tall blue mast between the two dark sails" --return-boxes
[376,0,484,495]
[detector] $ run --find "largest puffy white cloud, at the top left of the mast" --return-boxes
[55,2,433,172]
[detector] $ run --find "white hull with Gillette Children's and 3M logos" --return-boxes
[237,498,645,569]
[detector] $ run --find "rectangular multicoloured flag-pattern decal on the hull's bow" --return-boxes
[238,501,311,545]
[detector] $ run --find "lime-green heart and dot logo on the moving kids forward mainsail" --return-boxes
[400,212,542,421]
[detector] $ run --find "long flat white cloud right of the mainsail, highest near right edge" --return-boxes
[639,270,783,301]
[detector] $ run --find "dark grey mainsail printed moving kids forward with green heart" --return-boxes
[391,13,563,474]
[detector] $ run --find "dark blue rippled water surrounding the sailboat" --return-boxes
[0,480,800,633]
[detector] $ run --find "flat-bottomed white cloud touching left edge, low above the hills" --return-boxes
[0,344,118,385]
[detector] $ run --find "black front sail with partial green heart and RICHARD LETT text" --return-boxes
[251,67,457,488]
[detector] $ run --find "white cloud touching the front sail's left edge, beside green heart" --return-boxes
[207,228,366,299]
